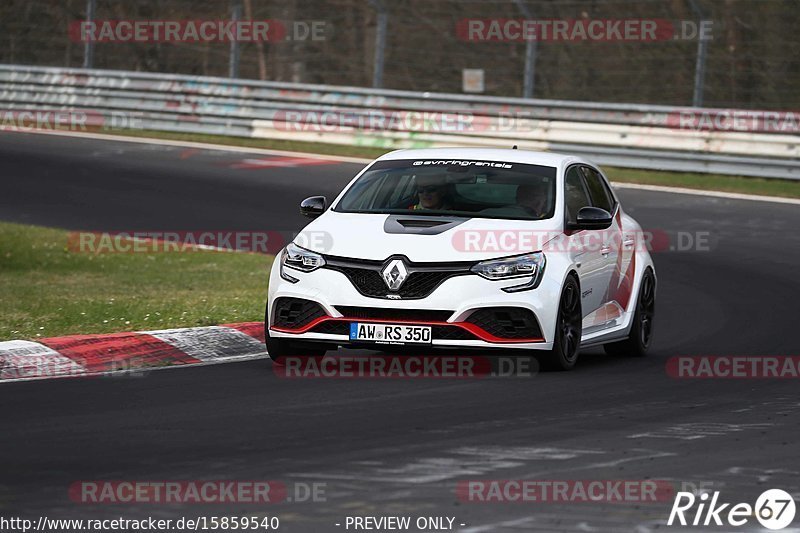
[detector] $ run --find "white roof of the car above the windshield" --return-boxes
[378,148,585,168]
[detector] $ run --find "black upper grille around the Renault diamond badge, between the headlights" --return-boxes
[325,257,472,299]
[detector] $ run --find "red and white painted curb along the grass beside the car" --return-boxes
[0,322,267,382]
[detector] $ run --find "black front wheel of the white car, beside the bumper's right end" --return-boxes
[542,275,583,371]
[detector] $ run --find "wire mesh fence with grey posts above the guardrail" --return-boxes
[0,0,800,109]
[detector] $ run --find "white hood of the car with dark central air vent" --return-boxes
[294,210,562,263]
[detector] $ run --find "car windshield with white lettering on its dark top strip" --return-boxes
[334,159,556,220]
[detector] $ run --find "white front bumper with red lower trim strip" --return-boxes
[268,261,559,350]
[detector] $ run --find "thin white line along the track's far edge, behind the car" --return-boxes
[7,130,800,205]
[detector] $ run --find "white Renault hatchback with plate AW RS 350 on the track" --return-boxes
[265,148,656,370]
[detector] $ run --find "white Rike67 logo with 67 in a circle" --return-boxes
[667,489,795,530]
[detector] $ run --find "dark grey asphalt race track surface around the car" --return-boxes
[0,133,800,531]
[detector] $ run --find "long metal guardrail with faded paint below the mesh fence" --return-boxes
[0,65,800,179]
